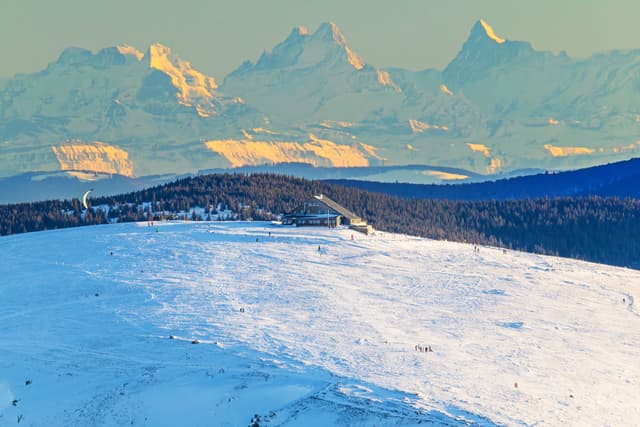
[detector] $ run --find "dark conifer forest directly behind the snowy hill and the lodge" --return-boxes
[0,174,640,268]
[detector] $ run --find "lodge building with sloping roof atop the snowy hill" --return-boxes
[282,194,373,234]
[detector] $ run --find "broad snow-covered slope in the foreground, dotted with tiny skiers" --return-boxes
[0,222,640,427]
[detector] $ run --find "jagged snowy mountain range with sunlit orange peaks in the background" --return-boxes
[0,20,640,180]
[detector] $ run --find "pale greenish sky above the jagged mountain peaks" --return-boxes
[0,0,640,81]
